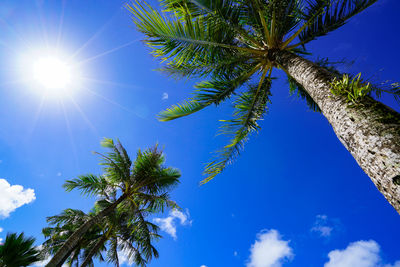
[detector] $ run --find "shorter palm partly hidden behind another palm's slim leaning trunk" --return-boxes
[42,207,159,267]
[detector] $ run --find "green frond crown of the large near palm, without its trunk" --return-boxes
[127,0,376,183]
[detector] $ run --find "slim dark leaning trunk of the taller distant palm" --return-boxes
[46,194,127,267]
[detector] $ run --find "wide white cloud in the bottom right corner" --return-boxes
[324,240,400,267]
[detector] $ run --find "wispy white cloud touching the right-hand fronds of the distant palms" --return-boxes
[153,209,192,240]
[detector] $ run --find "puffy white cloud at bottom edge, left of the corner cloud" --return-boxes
[246,229,294,267]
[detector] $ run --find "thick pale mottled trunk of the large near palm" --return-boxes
[270,51,400,213]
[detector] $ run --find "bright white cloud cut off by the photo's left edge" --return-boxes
[0,179,36,218]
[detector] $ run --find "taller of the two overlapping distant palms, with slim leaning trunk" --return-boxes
[46,138,180,267]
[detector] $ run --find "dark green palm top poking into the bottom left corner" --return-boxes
[0,233,41,267]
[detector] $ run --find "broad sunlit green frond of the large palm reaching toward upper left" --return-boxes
[128,1,252,69]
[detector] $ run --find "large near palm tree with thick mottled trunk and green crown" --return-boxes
[127,0,400,212]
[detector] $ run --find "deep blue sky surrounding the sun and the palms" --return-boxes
[0,0,400,267]
